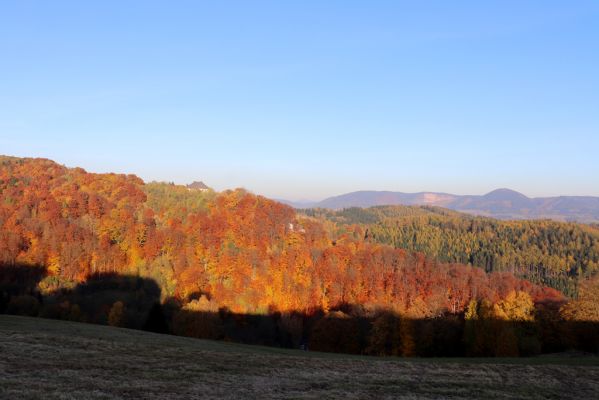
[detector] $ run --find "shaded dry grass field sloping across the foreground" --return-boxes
[0,315,599,399]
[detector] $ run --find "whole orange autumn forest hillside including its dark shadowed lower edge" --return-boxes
[0,157,599,356]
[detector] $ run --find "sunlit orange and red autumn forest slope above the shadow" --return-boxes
[0,158,560,315]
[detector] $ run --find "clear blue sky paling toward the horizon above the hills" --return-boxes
[0,0,599,199]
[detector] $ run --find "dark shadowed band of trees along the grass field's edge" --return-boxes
[0,266,599,357]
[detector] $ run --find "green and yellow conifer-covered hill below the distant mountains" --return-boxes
[302,206,599,295]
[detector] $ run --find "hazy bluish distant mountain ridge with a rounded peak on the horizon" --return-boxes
[286,189,599,223]
